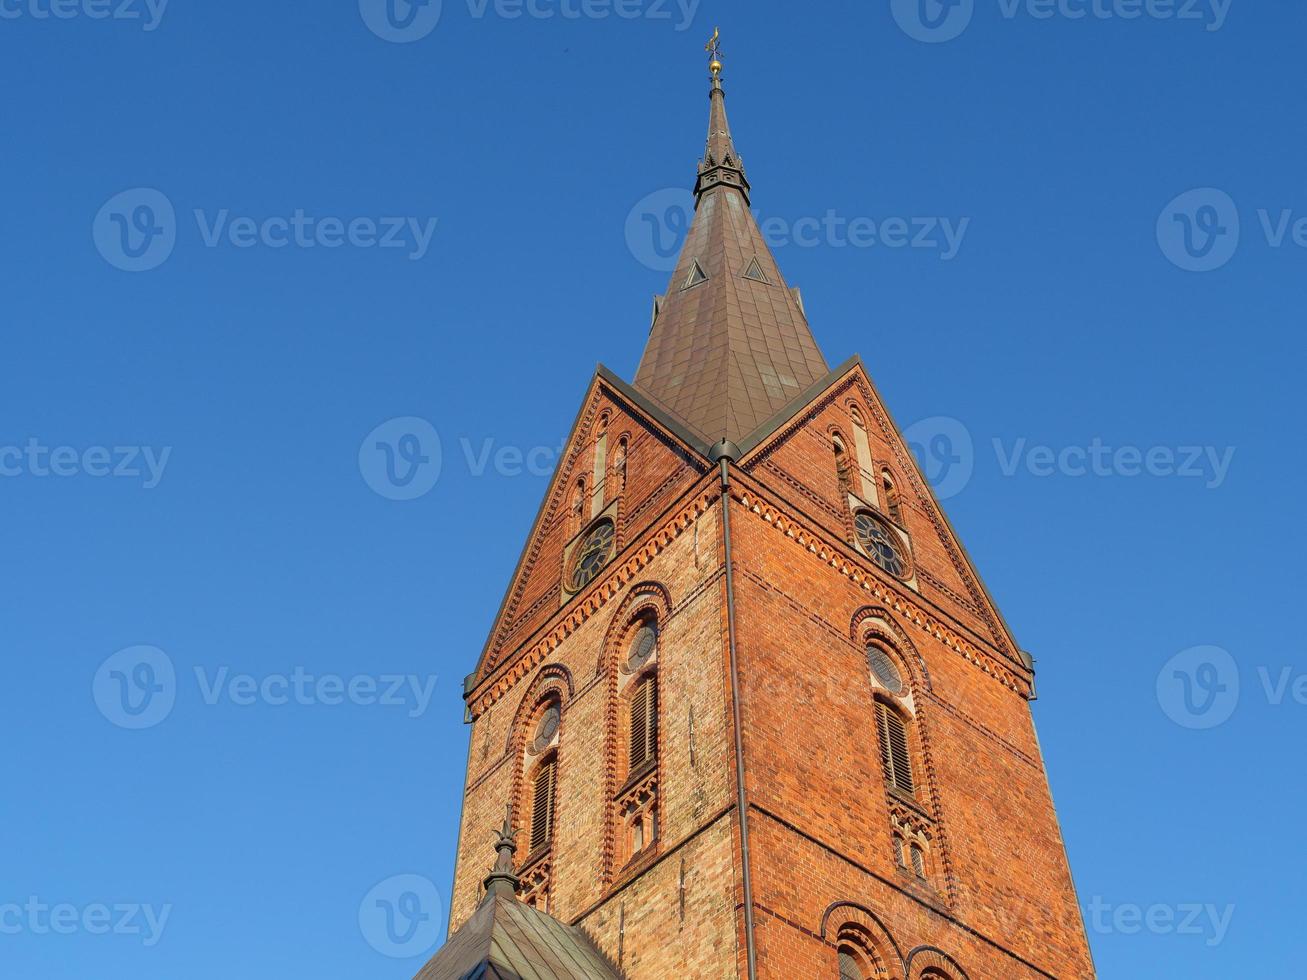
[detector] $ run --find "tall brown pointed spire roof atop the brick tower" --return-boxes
[635,35,829,444]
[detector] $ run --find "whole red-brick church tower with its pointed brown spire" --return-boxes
[418,43,1094,980]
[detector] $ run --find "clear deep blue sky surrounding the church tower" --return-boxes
[0,0,1307,980]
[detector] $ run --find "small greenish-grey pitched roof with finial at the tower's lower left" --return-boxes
[413,818,622,980]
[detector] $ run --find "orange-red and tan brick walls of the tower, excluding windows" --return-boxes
[451,367,1093,980]
